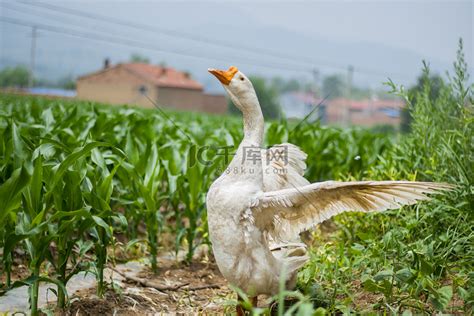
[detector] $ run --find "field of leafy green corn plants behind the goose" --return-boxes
[0,95,391,313]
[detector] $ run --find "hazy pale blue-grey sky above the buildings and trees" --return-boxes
[0,0,474,88]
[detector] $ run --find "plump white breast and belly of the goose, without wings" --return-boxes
[207,142,281,294]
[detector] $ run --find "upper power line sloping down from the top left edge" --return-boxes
[11,0,411,79]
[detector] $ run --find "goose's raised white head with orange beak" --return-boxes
[208,66,260,113]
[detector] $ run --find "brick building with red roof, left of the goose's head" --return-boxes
[77,62,227,114]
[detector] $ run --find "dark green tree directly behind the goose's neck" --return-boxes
[229,76,280,119]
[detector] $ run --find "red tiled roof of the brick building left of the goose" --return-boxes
[123,63,203,90]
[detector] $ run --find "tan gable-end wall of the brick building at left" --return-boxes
[77,67,157,108]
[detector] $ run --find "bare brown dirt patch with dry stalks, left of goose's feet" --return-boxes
[59,260,235,315]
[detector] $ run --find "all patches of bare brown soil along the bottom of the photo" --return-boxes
[0,251,463,316]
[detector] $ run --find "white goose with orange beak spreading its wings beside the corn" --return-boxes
[207,67,452,314]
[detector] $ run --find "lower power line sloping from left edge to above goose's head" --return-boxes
[0,16,308,73]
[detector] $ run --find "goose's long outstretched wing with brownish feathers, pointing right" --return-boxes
[252,181,454,241]
